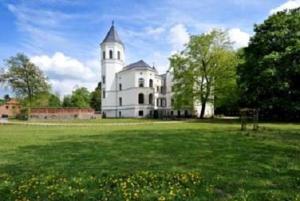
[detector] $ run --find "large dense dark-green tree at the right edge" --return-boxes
[238,8,300,119]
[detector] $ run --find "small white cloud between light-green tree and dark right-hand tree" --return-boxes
[228,28,250,49]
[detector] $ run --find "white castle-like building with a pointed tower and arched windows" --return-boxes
[101,24,214,117]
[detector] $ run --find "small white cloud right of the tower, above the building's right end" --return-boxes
[169,24,190,52]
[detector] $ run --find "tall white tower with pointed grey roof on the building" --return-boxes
[100,22,125,117]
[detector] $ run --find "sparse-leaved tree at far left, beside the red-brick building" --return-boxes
[0,54,50,109]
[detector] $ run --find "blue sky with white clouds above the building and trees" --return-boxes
[0,0,300,98]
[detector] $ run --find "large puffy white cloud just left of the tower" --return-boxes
[30,52,100,95]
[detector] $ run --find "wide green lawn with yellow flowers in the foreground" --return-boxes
[0,119,300,201]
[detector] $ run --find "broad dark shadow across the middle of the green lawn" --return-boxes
[0,129,300,199]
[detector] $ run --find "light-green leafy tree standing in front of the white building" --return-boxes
[170,30,238,118]
